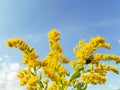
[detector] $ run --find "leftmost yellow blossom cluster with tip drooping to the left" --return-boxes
[6,38,41,90]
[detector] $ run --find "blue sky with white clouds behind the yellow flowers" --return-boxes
[0,0,120,90]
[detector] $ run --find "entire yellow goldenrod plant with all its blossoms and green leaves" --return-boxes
[6,29,120,90]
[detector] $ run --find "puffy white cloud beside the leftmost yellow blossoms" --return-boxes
[0,56,22,90]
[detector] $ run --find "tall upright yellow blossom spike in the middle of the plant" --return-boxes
[42,29,69,89]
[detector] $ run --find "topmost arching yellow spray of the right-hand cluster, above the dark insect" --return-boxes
[74,36,111,64]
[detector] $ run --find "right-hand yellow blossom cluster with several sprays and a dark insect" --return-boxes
[70,36,120,84]
